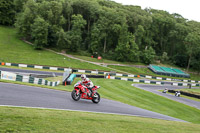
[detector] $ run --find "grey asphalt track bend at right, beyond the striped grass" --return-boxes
[133,84,200,109]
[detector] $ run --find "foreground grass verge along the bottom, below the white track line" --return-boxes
[0,107,200,133]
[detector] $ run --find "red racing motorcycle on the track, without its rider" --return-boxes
[71,81,100,103]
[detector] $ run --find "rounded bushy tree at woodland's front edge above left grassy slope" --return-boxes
[31,17,48,49]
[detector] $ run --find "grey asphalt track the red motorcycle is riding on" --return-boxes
[0,82,186,122]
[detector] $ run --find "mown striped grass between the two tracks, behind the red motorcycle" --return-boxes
[1,78,200,124]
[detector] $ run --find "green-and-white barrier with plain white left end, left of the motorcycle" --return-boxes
[0,71,60,86]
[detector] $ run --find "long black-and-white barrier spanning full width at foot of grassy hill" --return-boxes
[0,62,200,83]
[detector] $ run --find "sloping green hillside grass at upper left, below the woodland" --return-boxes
[0,26,110,71]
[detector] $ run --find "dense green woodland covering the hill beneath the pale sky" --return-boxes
[0,0,200,71]
